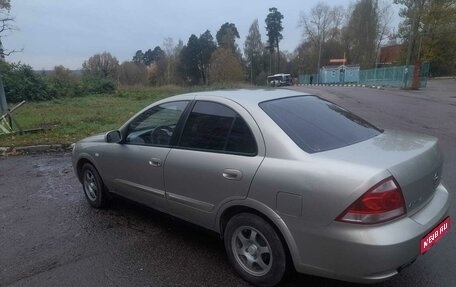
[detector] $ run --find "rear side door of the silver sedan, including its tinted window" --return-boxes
[165,100,264,228]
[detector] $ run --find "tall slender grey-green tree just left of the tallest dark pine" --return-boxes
[244,19,263,84]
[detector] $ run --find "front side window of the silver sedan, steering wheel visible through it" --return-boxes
[125,101,188,146]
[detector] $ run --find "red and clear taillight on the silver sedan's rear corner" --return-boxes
[337,177,405,224]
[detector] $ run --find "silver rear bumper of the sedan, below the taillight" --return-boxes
[291,185,451,283]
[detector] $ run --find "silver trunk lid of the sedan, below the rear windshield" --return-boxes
[320,130,443,214]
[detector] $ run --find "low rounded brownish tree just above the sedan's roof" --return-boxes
[209,47,244,83]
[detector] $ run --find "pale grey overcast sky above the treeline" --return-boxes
[2,0,398,70]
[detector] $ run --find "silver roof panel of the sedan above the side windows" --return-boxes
[171,89,310,105]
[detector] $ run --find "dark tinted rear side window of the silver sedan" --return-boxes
[179,101,257,155]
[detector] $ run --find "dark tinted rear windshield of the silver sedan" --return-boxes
[260,96,381,153]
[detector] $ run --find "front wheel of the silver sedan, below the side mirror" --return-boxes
[81,163,109,209]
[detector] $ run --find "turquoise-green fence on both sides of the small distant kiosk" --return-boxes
[299,62,430,88]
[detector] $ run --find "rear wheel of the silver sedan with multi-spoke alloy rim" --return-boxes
[224,213,287,287]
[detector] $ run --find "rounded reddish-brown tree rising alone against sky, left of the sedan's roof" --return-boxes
[82,52,119,79]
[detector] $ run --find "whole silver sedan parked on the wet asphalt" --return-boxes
[73,90,451,286]
